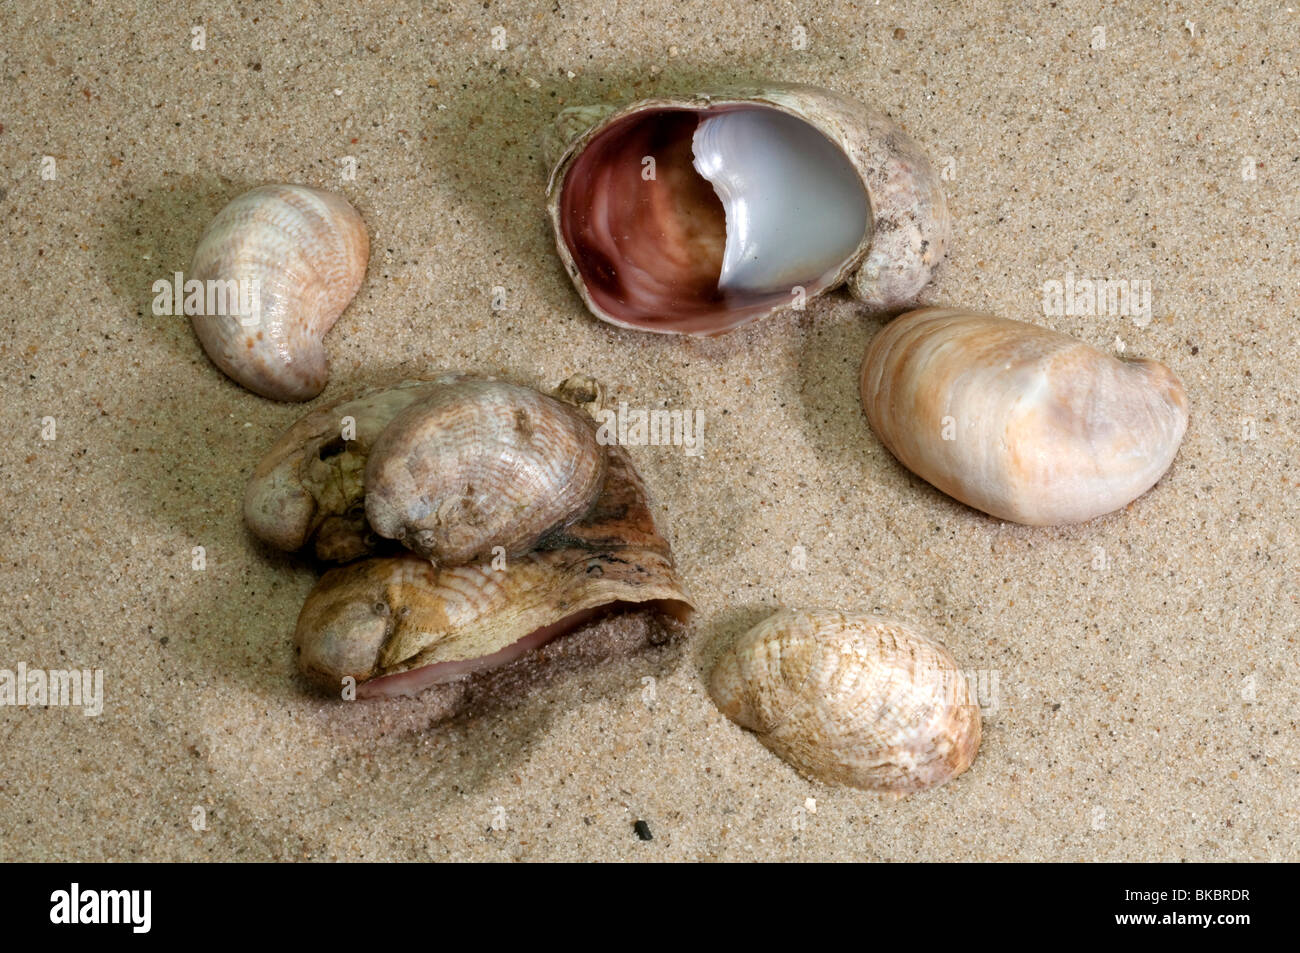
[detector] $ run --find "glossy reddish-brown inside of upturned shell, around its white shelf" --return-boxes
[558,103,870,334]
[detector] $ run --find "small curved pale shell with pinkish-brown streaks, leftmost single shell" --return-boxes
[191,185,371,400]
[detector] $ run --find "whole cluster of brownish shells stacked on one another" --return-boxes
[244,373,692,698]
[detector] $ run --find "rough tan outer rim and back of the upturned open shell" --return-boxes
[543,83,952,334]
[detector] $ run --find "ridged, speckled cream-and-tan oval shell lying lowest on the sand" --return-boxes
[709,610,980,794]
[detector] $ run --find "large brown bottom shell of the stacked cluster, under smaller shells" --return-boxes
[295,446,693,697]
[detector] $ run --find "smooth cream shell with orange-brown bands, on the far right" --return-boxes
[862,308,1188,525]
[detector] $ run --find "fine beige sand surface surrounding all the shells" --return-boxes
[0,0,1300,861]
